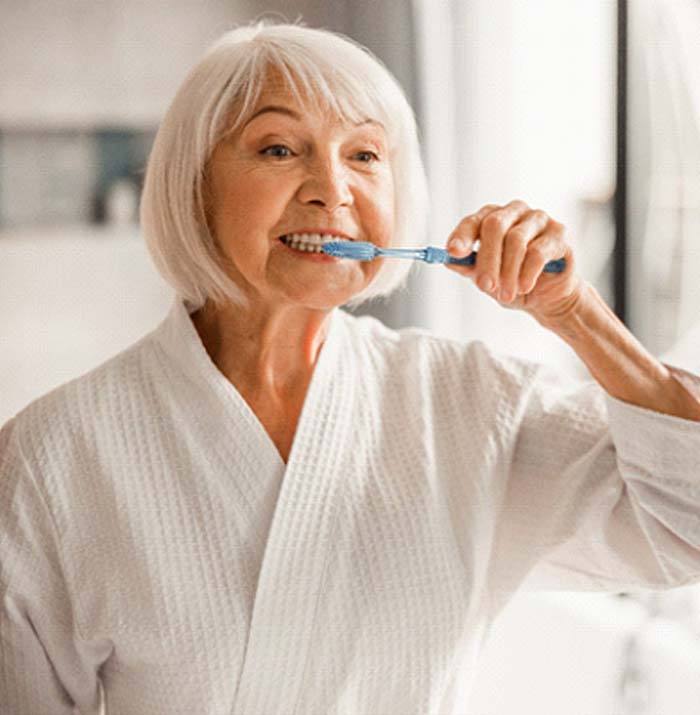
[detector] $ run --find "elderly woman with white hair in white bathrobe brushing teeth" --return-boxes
[0,23,700,715]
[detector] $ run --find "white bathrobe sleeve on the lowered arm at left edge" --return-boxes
[0,421,101,715]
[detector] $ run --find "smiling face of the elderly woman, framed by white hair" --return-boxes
[206,74,394,309]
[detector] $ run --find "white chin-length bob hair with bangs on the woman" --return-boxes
[140,20,429,307]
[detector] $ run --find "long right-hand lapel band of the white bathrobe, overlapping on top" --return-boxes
[233,310,355,715]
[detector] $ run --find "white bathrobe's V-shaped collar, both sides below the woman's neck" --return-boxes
[152,300,359,715]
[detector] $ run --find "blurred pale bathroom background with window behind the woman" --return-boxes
[0,0,700,715]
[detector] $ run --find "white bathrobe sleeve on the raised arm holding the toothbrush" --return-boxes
[482,350,700,599]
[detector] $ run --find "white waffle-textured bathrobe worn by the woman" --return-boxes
[0,300,700,715]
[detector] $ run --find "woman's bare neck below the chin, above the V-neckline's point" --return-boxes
[191,302,330,399]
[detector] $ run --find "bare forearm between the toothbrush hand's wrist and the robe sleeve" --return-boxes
[539,283,700,421]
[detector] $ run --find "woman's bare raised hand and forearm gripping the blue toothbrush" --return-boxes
[446,201,700,421]
